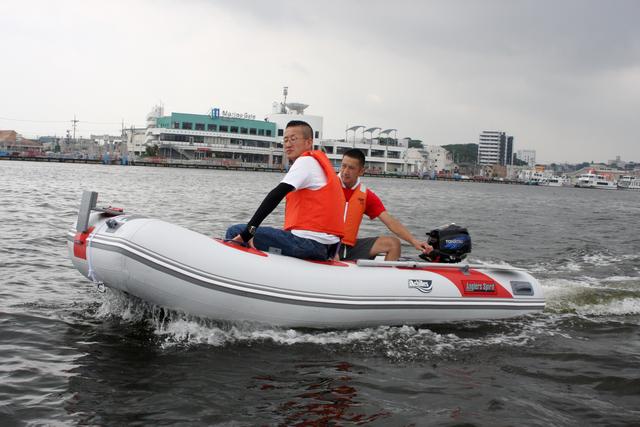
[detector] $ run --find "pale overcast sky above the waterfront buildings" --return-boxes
[0,0,640,162]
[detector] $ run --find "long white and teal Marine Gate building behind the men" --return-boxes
[142,101,426,174]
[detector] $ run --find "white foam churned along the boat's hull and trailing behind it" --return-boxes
[86,255,640,360]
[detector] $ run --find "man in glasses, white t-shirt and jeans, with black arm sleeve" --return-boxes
[226,120,345,260]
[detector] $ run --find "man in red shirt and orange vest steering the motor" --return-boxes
[339,149,433,261]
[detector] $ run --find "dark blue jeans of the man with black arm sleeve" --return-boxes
[225,224,331,261]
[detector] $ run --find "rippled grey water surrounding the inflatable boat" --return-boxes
[0,161,640,426]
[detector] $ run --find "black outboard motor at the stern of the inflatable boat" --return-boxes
[420,224,471,264]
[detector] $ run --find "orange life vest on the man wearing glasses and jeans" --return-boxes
[284,150,345,238]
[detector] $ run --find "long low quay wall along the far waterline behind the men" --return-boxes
[0,156,527,185]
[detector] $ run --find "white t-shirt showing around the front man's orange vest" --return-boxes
[281,156,340,245]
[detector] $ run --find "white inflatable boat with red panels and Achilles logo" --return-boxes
[67,192,545,328]
